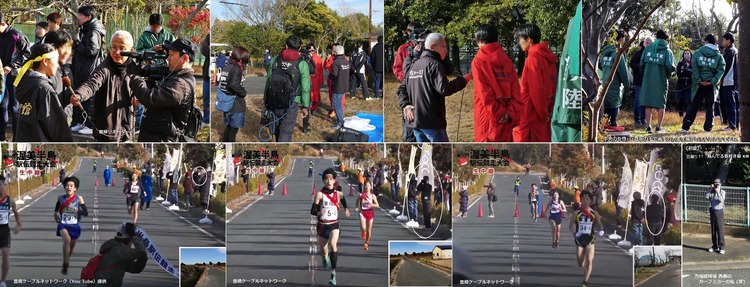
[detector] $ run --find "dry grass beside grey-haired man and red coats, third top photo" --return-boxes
[383,73,474,142]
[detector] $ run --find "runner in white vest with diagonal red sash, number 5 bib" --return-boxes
[310,168,349,285]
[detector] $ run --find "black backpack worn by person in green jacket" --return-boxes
[265,54,302,110]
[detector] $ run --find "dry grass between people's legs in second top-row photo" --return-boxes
[211,82,383,142]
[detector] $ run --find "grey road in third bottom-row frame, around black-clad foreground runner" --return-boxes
[453,174,633,286]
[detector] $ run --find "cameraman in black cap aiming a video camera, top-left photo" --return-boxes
[129,39,196,142]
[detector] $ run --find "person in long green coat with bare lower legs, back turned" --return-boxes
[639,30,675,133]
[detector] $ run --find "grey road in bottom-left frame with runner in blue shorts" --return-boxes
[7,158,223,287]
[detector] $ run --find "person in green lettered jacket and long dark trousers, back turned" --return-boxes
[681,34,726,134]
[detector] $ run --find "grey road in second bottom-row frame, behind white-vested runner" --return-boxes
[227,158,452,286]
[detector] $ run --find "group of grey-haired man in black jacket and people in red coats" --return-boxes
[393,22,557,142]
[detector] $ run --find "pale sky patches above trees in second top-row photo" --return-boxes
[211,0,384,26]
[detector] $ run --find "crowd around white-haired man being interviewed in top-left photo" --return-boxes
[0,6,208,142]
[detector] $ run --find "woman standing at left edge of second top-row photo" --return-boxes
[218,46,250,142]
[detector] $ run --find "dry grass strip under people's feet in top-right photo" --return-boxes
[605,111,740,142]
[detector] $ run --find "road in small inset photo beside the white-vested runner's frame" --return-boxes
[394,258,451,286]
